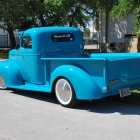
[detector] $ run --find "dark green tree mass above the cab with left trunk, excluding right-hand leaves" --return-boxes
[0,0,96,48]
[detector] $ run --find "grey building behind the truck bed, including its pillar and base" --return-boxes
[99,10,136,52]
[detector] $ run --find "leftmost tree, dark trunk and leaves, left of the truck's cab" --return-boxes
[0,0,31,48]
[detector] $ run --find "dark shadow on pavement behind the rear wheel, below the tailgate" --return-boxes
[76,98,140,115]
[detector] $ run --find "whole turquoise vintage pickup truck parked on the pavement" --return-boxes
[0,27,140,107]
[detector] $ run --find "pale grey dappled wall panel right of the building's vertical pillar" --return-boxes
[107,14,135,43]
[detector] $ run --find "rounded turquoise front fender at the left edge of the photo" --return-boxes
[0,60,24,87]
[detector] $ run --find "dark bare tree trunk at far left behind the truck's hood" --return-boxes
[7,26,16,49]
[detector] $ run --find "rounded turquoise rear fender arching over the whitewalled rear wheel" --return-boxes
[51,65,102,100]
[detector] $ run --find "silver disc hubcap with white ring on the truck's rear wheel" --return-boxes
[55,79,72,105]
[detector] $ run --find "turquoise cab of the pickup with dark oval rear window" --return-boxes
[9,27,84,85]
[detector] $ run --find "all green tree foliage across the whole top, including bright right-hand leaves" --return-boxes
[0,0,140,48]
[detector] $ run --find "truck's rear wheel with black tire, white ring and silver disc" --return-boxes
[55,78,79,107]
